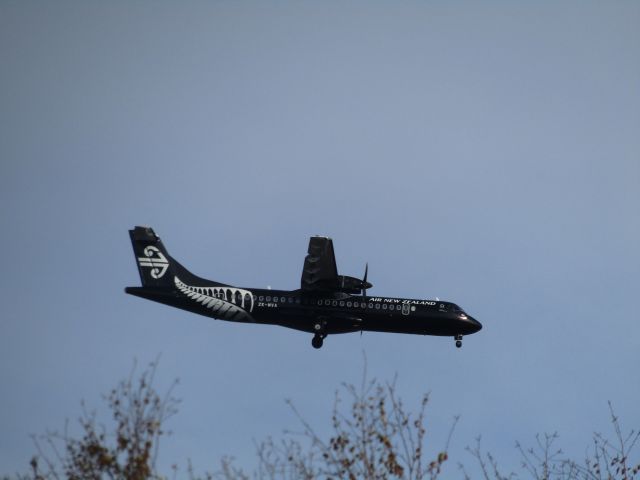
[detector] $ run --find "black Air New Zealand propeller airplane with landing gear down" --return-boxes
[125,226,482,348]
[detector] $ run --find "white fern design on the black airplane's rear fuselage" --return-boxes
[173,277,253,321]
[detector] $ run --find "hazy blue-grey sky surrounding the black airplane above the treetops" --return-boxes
[0,1,640,477]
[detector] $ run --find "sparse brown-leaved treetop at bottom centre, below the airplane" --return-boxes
[216,374,457,480]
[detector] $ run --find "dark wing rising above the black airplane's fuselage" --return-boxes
[300,237,338,292]
